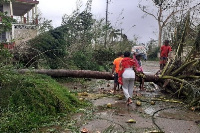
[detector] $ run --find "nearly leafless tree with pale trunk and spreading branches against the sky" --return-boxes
[139,0,200,47]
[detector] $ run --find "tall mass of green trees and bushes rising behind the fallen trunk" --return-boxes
[14,4,133,71]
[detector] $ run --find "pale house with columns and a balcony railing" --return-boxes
[0,0,39,49]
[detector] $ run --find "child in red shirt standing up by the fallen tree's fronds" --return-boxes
[160,40,172,70]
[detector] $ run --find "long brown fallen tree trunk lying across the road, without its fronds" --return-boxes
[18,69,159,82]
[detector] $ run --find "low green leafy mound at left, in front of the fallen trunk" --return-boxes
[0,68,86,133]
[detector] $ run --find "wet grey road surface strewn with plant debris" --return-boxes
[64,62,200,133]
